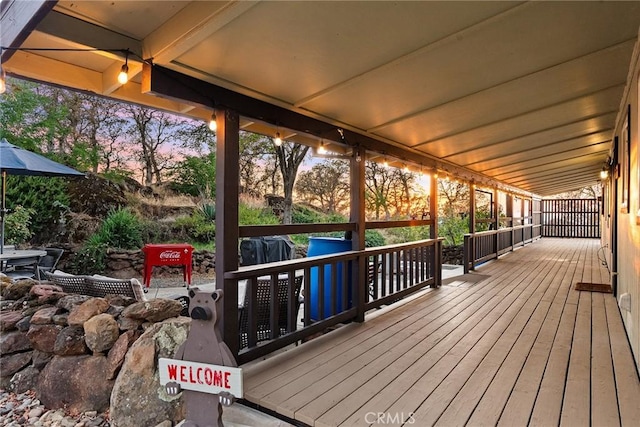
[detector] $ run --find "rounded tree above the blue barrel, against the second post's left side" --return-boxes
[296,160,349,214]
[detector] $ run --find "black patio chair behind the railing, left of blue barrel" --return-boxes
[239,276,303,348]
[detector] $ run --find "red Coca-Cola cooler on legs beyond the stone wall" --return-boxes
[142,243,193,292]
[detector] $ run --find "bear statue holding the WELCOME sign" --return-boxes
[165,287,238,427]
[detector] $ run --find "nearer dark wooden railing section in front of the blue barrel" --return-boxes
[224,239,442,364]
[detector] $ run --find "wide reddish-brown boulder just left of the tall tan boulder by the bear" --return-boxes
[36,356,114,416]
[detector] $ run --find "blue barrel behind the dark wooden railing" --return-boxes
[305,237,353,320]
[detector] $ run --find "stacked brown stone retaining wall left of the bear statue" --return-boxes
[0,277,191,427]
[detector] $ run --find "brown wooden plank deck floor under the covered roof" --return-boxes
[244,239,640,427]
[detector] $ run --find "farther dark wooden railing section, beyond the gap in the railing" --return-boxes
[463,224,541,274]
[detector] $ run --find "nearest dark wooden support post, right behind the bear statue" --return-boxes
[216,108,240,357]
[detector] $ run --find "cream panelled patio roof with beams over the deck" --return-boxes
[0,0,640,196]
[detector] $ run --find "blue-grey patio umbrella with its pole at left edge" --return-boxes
[0,138,84,254]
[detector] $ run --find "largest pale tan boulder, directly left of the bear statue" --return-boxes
[110,317,191,427]
